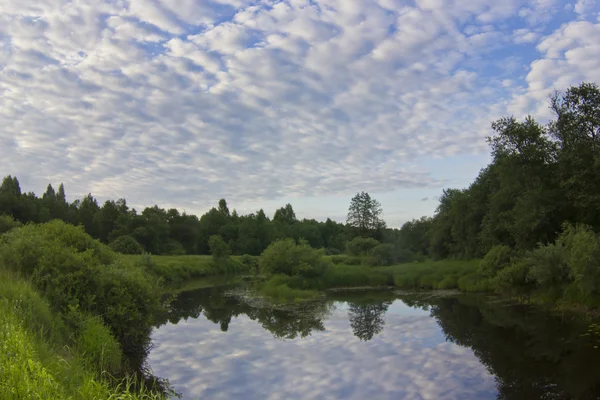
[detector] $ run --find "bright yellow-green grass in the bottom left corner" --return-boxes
[0,270,164,400]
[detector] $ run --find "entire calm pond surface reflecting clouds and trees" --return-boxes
[149,287,600,399]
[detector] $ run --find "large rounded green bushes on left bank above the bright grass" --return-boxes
[0,220,161,357]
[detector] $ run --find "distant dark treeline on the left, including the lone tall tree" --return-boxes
[0,176,397,255]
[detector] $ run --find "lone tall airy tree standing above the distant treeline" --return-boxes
[346,192,385,236]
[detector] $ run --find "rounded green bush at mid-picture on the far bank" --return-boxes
[259,239,329,278]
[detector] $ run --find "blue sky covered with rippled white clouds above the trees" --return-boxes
[0,0,600,227]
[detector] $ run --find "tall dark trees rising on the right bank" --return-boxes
[401,83,600,259]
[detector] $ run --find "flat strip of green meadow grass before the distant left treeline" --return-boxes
[121,255,250,284]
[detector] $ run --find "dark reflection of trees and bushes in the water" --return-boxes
[155,286,600,400]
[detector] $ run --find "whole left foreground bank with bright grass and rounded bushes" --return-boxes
[0,221,165,399]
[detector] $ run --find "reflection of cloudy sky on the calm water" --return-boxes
[149,300,497,400]
